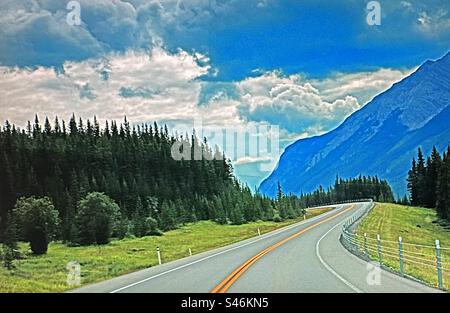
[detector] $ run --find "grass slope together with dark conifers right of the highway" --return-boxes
[356,146,450,290]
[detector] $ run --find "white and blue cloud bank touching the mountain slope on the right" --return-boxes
[199,69,414,136]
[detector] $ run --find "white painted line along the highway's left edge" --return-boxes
[109,204,343,293]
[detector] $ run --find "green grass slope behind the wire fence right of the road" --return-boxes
[357,203,450,290]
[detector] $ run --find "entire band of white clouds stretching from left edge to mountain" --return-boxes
[0,47,409,142]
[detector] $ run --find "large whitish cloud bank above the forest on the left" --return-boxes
[0,48,210,125]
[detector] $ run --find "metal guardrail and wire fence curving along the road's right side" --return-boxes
[341,204,450,290]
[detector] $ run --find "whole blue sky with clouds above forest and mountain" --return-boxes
[0,0,450,187]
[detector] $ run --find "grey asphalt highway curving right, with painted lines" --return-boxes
[72,202,439,293]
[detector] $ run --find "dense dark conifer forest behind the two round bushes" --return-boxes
[0,116,303,246]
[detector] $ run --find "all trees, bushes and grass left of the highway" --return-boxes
[0,116,393,292]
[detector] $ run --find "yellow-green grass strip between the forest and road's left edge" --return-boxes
[0,209,330,292]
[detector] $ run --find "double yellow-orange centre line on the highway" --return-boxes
[211,205,354,293]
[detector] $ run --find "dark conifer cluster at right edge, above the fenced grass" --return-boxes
[407,146,450,219]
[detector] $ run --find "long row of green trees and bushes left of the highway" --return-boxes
[0,115,392,266]
